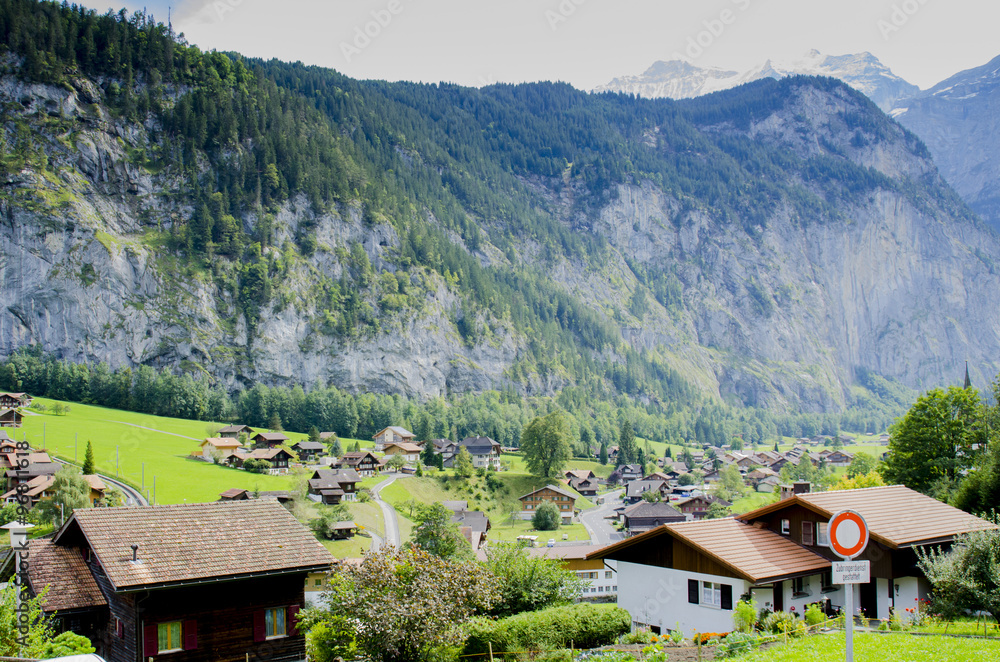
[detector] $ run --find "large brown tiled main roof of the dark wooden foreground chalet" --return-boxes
[55,499,333,590]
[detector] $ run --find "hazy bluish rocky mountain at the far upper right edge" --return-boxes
[892,57,1000,236]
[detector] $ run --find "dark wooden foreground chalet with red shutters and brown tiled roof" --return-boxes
[21,500,333,662]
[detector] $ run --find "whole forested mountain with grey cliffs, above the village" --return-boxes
[0,0,1000,411]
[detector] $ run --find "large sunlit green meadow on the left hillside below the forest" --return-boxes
[16,398,306,503]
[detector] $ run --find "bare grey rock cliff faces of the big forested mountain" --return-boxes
[0,76,1000,410]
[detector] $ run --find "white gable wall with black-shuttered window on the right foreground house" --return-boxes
[618,561,749,636]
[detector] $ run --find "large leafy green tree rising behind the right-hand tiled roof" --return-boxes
[881,386,986,493]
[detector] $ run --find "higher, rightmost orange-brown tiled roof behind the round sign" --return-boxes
[740,485,996,548]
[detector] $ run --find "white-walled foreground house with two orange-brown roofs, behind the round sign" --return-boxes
[587,485,995,632]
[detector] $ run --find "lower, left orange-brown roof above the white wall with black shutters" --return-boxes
[587,517,830,583]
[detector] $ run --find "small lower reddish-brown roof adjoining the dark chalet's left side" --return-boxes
[28,539,108,612]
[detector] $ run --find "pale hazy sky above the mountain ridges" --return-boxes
[83,0,1000,90]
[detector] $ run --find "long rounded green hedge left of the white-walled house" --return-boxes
[463,603,624,655]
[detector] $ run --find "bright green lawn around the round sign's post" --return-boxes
[740,633,1000,662]
